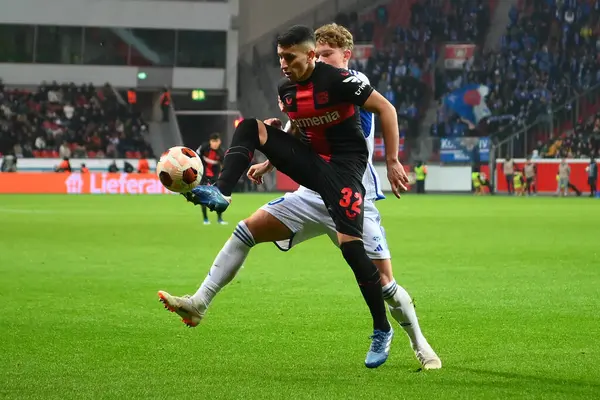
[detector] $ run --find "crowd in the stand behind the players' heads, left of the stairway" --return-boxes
[336,0,490,135]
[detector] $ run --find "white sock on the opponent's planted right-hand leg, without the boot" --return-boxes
[383,281,427,348]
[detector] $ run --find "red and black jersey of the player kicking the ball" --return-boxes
[278,62,373,162]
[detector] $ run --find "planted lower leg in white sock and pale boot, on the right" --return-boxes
[383,280,442,369]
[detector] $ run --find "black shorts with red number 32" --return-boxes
[259,126,367,239]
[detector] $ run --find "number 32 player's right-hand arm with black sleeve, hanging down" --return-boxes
[334,70,408,197]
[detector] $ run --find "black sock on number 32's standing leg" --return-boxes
[340,240,391,332]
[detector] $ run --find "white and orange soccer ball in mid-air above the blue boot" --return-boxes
[156,146,204,193]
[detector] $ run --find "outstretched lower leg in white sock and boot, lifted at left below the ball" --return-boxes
[158,222,255,327]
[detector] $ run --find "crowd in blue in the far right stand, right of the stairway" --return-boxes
[431,0,600,144]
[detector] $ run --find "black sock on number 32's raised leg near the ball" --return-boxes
[217,118,260,196]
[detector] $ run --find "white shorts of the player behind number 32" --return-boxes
[260,189,391,260]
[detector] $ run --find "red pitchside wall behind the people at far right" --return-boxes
[495,158,590,193]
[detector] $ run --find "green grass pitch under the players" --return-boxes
[0,195,600,400]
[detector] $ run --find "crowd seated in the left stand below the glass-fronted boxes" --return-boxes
[0,80,152,158]
